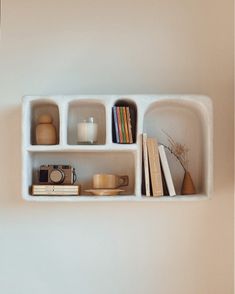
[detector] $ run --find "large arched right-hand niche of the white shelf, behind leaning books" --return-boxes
[143,95,213,197]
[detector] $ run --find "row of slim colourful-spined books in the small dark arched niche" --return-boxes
[113,106,135,144]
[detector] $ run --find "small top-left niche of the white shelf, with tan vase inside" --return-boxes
[24,97,60,145]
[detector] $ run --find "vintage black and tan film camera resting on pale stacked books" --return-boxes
[39,165,77,185]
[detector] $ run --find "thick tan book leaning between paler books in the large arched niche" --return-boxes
[147,138,164,196]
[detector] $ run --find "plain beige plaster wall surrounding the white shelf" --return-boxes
[0,0,233,294]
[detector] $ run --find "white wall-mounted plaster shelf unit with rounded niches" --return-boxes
[22,95,213,202]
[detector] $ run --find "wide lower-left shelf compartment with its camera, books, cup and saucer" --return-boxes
[23,151,136,199]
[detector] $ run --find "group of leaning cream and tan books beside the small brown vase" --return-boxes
[142,133,176,196]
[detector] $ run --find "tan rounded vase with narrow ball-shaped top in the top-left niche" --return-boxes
[36,114,57,145]
